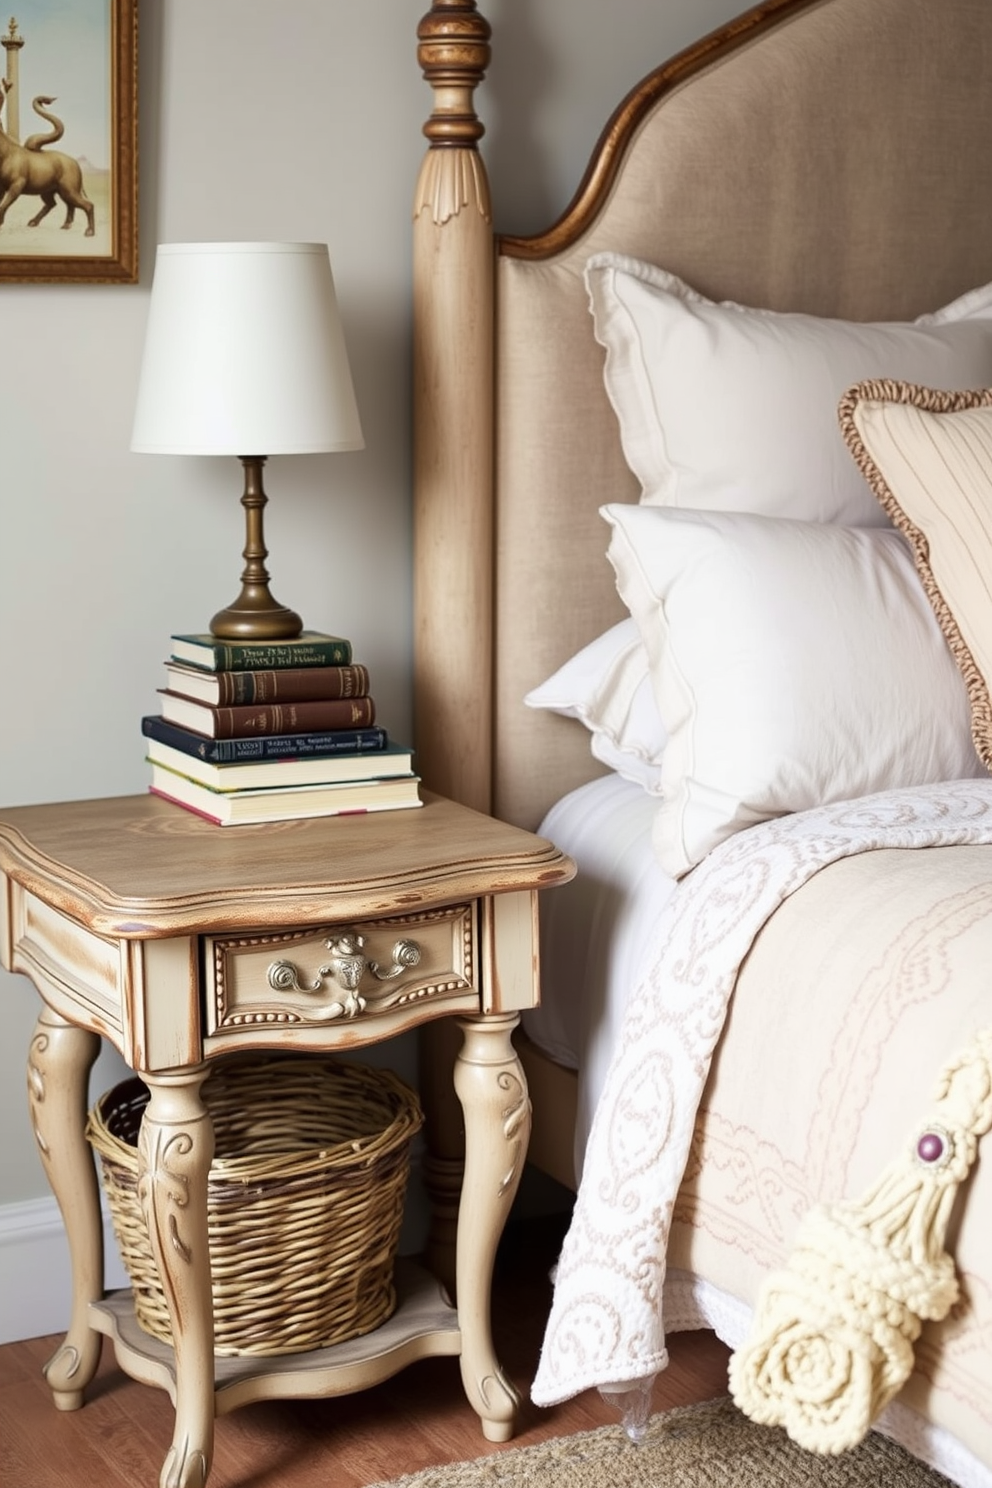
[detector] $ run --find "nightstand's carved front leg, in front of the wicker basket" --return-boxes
[138,1064,214,1488]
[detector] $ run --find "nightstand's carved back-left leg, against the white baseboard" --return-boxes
[28,1007,104,1411]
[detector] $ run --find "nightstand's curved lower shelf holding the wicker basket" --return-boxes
[89,1259,461,1415]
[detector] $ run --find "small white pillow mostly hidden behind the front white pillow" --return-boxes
[524,620,666,796]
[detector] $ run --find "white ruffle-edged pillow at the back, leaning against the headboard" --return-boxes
[586,253,992,527]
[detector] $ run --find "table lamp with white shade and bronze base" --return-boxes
[131,243,363,640]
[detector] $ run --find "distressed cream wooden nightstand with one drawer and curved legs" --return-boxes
[0,796,574,1488]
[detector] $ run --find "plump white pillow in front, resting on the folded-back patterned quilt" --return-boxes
[601,504,983,878]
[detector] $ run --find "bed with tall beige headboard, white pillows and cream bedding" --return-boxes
[413,0,992,1488]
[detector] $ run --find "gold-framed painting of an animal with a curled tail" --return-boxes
[0,0,138,284]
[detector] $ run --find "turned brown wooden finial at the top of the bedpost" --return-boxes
[416,0,492,150]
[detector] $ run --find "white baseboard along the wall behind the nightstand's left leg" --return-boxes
[0,1198,128,1344]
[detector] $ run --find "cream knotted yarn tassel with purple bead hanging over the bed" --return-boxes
[730,1028,992,1455]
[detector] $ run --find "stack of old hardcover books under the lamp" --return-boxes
[141,631,421,826]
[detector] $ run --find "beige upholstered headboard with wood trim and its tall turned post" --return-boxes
[413,0,992,827]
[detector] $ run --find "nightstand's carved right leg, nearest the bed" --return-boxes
[455,1013,531,1442]
